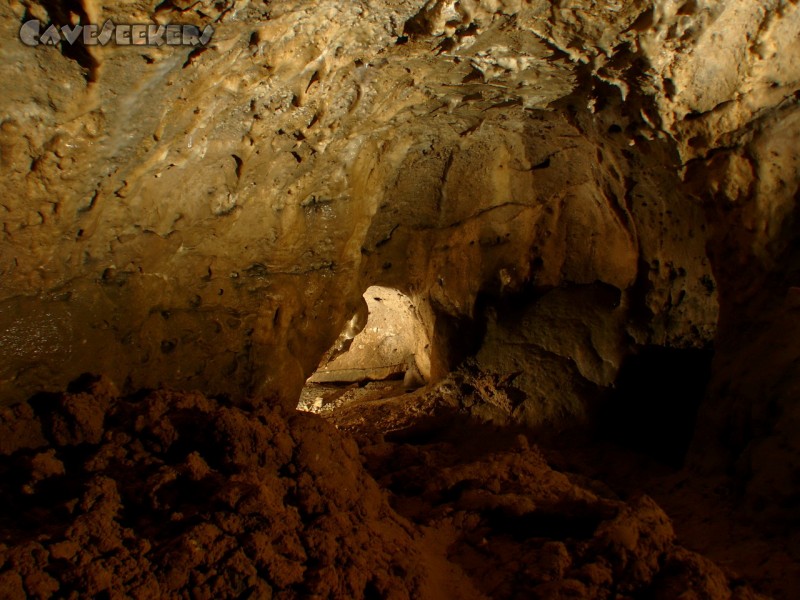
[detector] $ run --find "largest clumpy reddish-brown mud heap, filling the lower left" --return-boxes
[0,380,422,599]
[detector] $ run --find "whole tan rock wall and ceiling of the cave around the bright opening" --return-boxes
[0,0,800,510]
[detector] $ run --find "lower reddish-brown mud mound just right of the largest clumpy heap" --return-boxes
[364,436,761,600]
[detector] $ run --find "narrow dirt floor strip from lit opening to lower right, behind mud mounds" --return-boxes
[316,381,800,600]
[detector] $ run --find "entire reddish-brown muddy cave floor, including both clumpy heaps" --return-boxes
[0,379,796,600]
